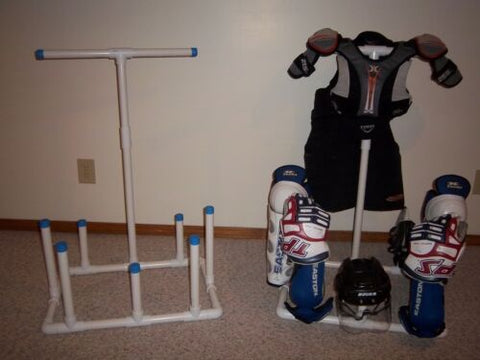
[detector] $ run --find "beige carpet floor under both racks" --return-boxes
[0,231,480,360]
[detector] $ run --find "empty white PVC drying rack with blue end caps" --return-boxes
[35,48,223,334]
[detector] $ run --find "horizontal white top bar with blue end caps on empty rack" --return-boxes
[35,47,198,60]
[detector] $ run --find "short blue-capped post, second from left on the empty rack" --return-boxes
[55,241,76,329]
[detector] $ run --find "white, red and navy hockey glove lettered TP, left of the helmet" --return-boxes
[280,194,330,264]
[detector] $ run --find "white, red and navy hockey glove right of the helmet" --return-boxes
[402,215,466,282]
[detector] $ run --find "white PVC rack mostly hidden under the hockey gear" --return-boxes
[276,46,406,333]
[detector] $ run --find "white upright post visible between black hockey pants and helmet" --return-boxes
[351,139,371,259]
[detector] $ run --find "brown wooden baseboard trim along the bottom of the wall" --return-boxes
[0,219,480,245]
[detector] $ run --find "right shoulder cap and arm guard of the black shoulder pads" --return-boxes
[413,34,462,88]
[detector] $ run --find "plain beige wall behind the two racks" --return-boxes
[0,0,480,234]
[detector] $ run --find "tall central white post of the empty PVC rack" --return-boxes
[115,55,138,263]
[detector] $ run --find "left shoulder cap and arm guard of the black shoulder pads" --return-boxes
[288,28,341,79]
